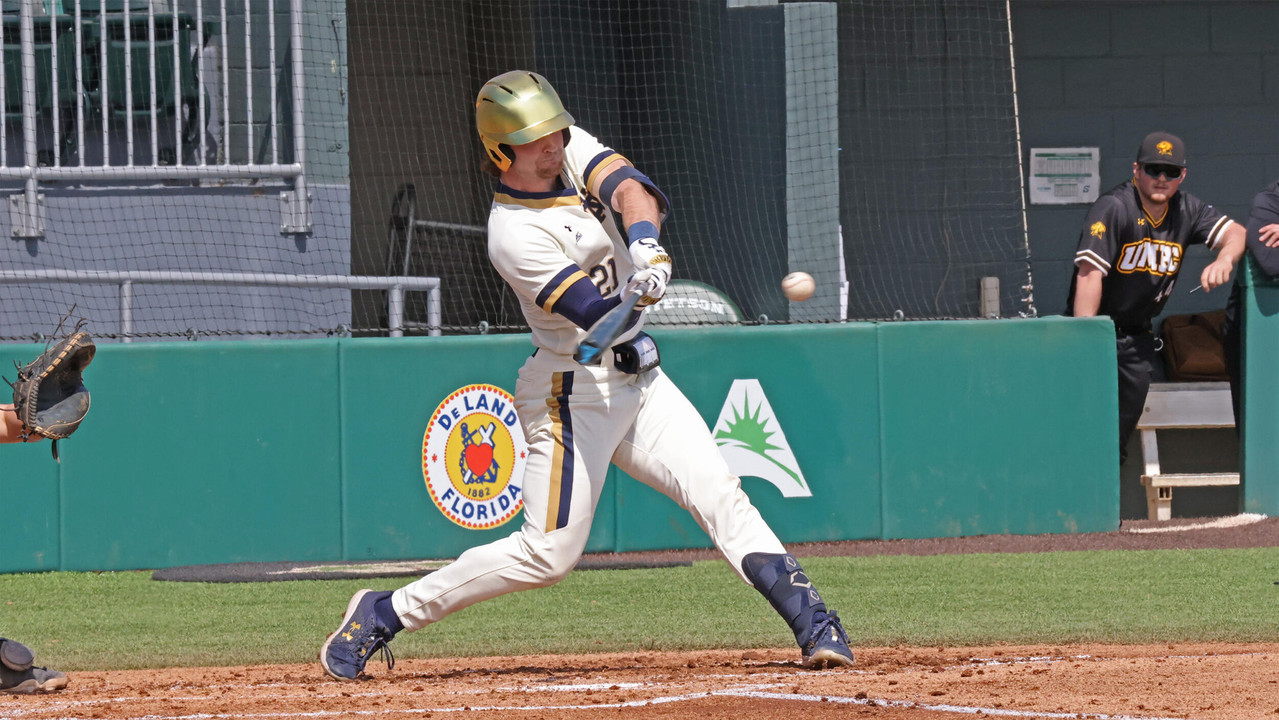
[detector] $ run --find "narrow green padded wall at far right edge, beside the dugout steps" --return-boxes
[1238,254,1279,515]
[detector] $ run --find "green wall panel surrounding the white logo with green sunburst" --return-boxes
[616,324,880,551]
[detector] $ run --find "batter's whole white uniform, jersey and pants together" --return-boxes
[391,127,785,630]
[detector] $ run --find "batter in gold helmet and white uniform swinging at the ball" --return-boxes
[320,70,853,680]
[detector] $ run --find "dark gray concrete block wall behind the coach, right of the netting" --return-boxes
[1012,0,1279,322]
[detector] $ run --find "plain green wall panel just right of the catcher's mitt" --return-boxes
[61,340,340,570]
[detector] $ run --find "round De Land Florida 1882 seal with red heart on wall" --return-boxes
[422,385,528,529]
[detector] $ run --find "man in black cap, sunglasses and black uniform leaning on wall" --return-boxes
[1065,133,1244,463]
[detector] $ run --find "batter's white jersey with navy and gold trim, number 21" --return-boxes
[489,127,643,356]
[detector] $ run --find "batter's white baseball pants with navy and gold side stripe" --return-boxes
[391,349,785,630]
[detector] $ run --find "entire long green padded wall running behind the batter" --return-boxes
[0,318,1119,572]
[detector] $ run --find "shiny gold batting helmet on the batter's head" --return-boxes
[476,70,573,171]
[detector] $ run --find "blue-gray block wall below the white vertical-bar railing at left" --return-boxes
[0,184,350,341]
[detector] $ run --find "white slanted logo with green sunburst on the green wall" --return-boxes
[711,380,812,497]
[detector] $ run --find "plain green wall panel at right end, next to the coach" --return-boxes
[879,317,1119,537]
